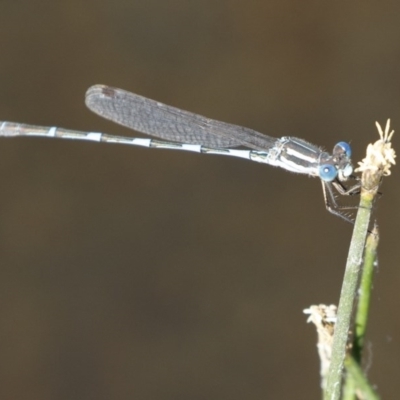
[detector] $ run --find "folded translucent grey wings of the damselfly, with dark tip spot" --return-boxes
[86,85,276,150]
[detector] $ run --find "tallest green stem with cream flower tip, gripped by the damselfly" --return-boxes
[324,120,396,400]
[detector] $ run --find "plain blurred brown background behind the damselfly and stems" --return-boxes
[0,0,400,400]
